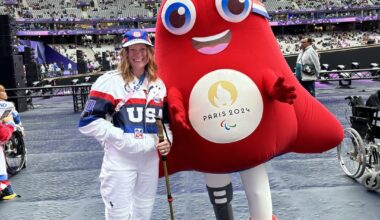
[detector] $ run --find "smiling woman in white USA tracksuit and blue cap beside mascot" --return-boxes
[79,30,171,220]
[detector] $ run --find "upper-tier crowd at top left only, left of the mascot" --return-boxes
[0,0,154,20]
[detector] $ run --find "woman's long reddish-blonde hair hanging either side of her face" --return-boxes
[118,46,157,83]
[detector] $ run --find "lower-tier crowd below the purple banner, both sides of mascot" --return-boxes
[46,31,380,72]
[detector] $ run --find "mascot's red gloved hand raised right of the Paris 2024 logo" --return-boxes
[271,77,297,105]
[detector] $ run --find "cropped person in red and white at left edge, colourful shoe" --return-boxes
[0,115,17,200]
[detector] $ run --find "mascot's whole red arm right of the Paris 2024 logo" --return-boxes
[264,74,297,105]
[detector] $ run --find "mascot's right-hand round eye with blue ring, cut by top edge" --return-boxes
[215,0,252,23]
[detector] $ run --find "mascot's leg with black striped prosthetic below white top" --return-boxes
[204,173,234,220]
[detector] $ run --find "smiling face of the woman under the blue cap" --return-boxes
[127,44,148,72]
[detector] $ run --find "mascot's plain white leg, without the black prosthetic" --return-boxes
[240,164,276,220]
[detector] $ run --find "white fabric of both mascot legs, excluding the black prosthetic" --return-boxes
[205,164,272,220]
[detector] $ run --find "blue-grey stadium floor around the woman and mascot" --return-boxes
[0,80,380,220]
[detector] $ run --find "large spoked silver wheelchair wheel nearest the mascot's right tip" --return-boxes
[337,128,366,178]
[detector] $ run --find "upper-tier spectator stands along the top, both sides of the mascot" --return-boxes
[0,0,380,19]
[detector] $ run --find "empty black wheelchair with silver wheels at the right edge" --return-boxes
[337,96,380,191]
